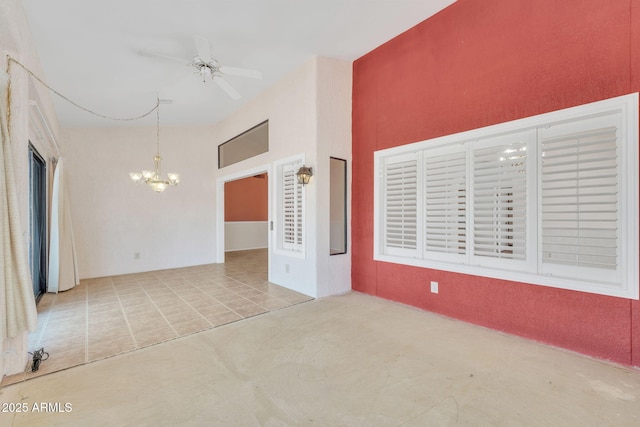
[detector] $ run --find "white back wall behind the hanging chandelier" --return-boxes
[62,124,215,278]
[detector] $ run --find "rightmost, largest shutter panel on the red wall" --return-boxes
[542,126,619,269]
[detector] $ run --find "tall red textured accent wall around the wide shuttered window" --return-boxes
[351,0,640,366]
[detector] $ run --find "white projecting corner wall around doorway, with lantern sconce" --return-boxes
[213,58,352,297]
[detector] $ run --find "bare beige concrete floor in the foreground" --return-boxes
[0,293,640,427]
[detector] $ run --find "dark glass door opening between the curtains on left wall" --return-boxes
[29,143,47,302]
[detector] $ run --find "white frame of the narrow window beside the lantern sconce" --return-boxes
[273,154,307,258]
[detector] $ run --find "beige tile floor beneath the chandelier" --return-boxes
[2,250,311,386]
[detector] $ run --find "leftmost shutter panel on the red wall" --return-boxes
[382,153,418,256]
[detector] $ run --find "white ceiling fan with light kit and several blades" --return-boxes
[147,34,262,99]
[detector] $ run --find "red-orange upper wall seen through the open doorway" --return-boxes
[224,174,269,222]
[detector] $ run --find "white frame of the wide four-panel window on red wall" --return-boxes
[373,93,640,300]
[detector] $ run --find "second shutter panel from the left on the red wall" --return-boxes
[424,147,467,260]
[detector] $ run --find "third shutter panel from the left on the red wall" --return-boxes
[473,133,527,263]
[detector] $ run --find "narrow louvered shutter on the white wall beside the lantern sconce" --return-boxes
[280,162,304,251]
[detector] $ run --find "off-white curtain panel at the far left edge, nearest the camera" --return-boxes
[0,71,38,340]
